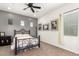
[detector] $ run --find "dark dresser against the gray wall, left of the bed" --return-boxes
[0,36,11,46]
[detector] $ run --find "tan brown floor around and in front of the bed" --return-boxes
[0,42,78,56]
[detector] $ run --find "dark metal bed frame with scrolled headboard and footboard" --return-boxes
[14,29,40,55]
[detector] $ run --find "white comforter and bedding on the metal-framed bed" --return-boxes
[11,34,38,50]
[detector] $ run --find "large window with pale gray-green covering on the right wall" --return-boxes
[64,12,78,36]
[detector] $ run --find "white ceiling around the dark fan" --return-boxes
[0,3,63,18]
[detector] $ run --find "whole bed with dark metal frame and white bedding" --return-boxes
[11,29,40,55]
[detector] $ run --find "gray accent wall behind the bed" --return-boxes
[0,11,37,36]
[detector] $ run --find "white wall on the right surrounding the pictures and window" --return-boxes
[38,4,79,54]
